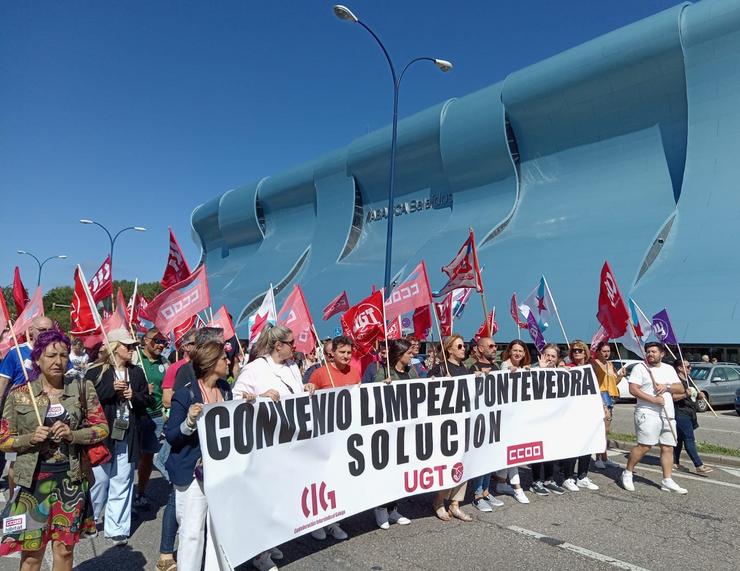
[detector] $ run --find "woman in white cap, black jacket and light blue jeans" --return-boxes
[85,329,154,545]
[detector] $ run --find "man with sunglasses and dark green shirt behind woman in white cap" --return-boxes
[134,327,170,509]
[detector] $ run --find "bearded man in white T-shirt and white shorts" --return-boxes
[622,342,688,494]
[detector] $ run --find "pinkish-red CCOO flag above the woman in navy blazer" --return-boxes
[144,265,211,335]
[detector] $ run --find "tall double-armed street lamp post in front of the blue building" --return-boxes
[334,4,452,295]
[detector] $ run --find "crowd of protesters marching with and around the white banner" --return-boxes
[0,317,711,571]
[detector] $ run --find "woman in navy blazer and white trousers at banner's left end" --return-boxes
[165,341,243,571]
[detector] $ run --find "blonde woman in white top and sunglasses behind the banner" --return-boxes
[232,324,316,571]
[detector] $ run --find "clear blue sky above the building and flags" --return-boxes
[0,0,677,289]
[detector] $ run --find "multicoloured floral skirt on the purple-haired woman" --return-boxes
[0,470,96,556]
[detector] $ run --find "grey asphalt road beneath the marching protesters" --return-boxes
[0,444,740,571]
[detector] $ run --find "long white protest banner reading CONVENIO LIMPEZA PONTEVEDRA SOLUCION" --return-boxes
[198,365,605,567]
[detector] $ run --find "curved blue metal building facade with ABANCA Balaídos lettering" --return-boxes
[192,0,740,343]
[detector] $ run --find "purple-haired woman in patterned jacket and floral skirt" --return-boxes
[0,330,108,570]
